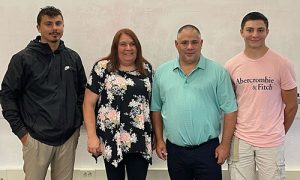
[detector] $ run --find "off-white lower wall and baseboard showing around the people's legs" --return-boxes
[0,112,300,180]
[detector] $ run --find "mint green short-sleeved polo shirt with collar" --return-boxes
[151,56,237,146]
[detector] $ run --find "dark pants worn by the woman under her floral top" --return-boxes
[104,153,149,180]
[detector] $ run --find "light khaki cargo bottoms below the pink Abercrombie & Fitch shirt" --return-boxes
[227,137,285,180]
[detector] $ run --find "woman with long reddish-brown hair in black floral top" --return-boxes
[83,29,152,180]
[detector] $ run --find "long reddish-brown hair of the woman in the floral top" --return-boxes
[101,28,148,75]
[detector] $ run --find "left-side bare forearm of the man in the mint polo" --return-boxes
[151,112,163,142]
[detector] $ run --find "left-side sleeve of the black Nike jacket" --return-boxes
[0,53,27,138]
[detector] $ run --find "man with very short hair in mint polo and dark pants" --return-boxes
[151,25,237,180]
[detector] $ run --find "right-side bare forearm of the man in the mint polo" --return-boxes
[221,112,237,147]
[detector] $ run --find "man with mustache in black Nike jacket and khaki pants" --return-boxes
[0,6,86,180]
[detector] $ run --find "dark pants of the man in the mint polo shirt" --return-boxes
[167,138,222,180]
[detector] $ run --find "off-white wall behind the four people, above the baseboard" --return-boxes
[0,0,300,175]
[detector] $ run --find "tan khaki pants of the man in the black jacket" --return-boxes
[23,129,80,180]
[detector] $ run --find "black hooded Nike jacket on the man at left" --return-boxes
[0,36,86,146]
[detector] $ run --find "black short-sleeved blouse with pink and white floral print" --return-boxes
[87,60,152,167]
